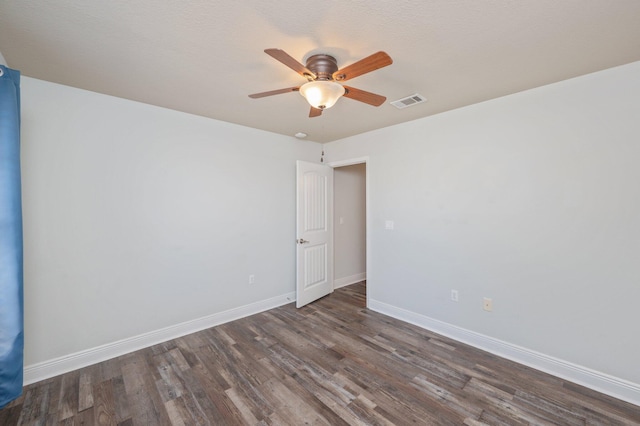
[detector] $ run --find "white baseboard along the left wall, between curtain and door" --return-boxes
[24,292,296,385]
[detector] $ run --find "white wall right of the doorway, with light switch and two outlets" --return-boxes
[325,62,640,403]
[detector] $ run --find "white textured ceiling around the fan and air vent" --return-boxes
[0,0,640,142]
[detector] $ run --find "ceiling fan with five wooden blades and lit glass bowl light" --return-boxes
[249,49,393,117]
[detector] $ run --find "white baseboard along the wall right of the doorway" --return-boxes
[369,300,640,406]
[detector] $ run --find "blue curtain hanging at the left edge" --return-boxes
[0,65,24,408]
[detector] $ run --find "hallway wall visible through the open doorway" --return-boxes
[333,163,367,287]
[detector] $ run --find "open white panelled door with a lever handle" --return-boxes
[296,161,333,308]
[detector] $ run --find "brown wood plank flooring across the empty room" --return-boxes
[0,283,640,426]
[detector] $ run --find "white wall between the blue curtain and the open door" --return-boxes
[21,77,321,369]
